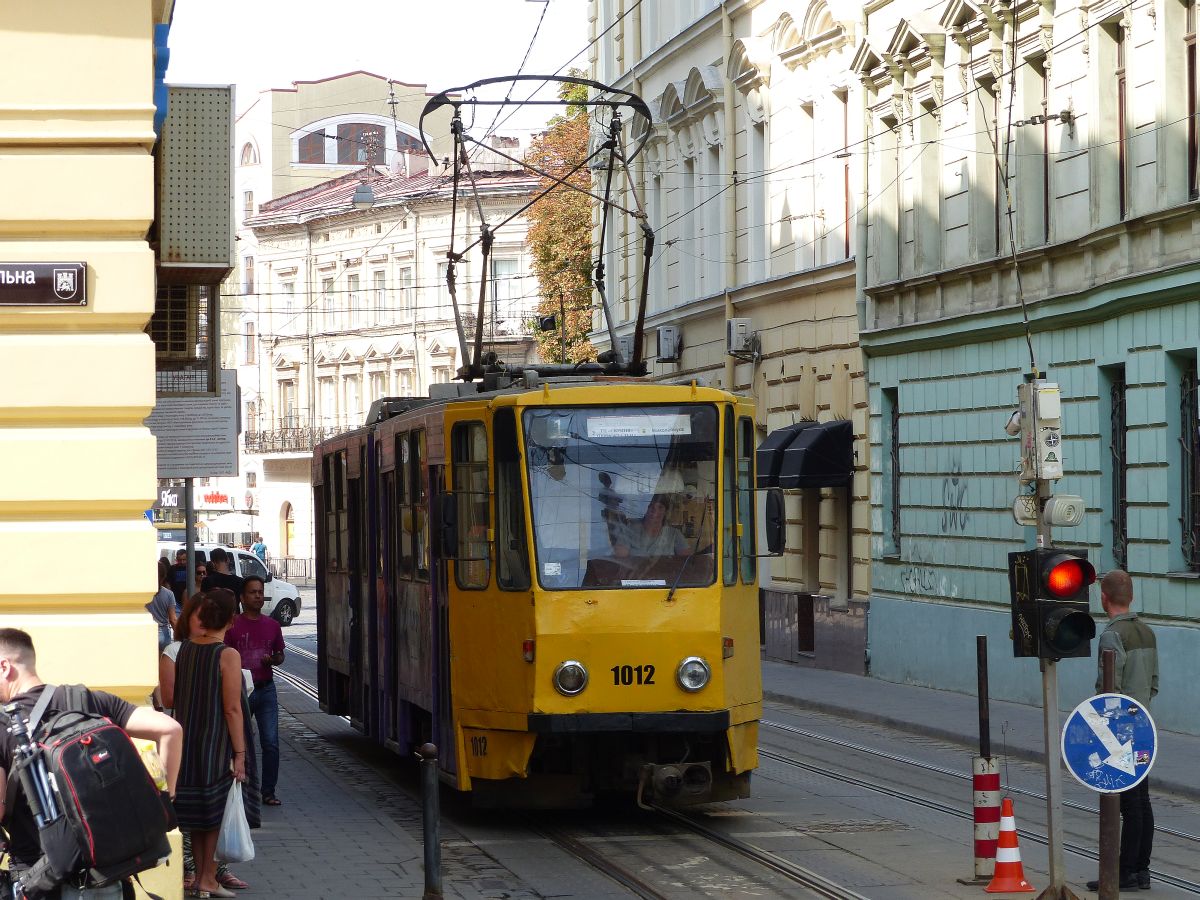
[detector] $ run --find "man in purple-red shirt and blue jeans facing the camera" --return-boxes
[226,575,283,806]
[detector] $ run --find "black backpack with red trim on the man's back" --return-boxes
[10,684,175,900]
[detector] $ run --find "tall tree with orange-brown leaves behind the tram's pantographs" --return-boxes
[527,71,596,362]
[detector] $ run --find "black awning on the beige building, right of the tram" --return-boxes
[756,419,854,487]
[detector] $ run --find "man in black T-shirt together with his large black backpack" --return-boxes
[0,628,182,900]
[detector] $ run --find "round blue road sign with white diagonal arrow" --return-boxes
[1062,694,1158,793]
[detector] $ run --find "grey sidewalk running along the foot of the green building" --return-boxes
[762,660,1200,799]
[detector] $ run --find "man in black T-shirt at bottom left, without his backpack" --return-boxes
[0,628,184,869]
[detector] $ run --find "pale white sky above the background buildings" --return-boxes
[167,0,588,128]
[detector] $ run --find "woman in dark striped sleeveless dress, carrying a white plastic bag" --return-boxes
[174,588,259,898]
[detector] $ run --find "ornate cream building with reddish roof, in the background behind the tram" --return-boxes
[211,167,539,566]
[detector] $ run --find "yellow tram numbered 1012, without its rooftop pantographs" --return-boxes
[313,377,782,806]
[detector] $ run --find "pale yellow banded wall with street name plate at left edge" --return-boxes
[0,0,170,703]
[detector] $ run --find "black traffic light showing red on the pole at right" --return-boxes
[1008,547,1096,659]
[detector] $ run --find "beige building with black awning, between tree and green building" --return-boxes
[590,0,870,671]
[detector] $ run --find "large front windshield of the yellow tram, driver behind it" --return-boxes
[524,404,718,590]
